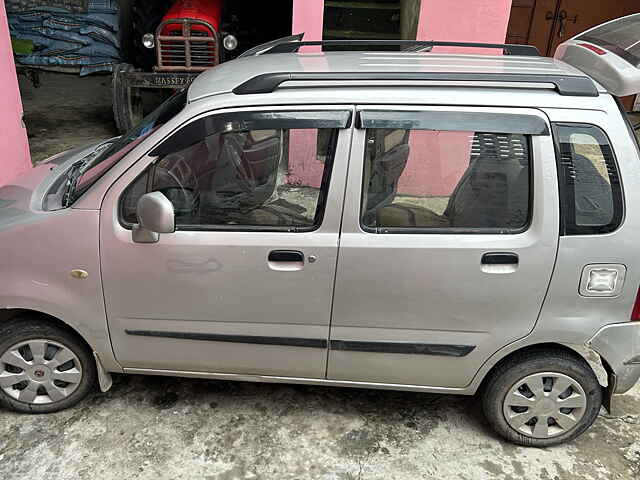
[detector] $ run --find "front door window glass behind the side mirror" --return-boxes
[121,124,339,231]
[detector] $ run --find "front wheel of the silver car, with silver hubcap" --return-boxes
[0,318,97,413]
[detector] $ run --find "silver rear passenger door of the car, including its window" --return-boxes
[327,106,559,388]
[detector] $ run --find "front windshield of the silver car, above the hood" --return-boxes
[69,89,187,204]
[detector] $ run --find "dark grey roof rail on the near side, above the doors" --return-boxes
[233,72,598,97]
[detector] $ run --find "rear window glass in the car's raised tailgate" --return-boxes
[576,14,640,67]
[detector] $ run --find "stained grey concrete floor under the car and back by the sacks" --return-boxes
[0,75,640,480]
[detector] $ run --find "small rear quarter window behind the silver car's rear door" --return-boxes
[555,124,622,235]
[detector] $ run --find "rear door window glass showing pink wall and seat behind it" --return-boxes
[362,129,530,233]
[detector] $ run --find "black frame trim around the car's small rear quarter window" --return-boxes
[551,121,626,237]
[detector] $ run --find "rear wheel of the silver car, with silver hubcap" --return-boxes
[482,349,602,447]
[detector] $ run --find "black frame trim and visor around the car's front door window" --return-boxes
[116,104,354,233]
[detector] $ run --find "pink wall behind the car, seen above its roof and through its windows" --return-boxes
[289,0,511,191]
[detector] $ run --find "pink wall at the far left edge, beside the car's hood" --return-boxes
[0,2,31,185]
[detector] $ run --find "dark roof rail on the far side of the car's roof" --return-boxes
[239,38,540,58]
